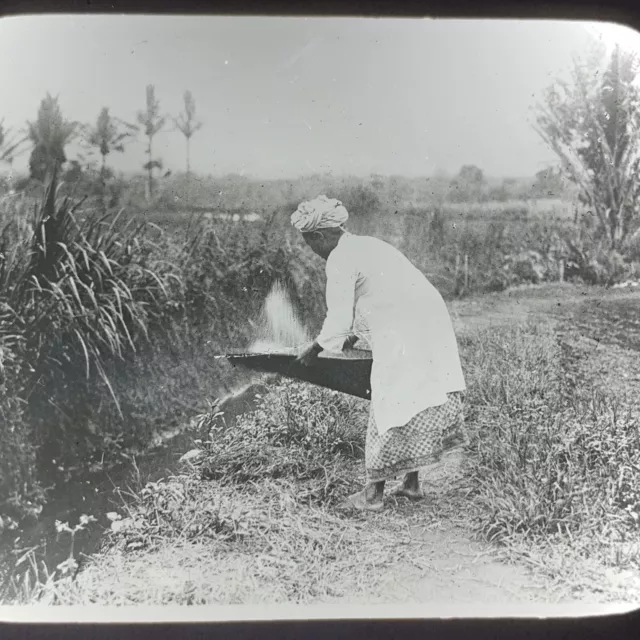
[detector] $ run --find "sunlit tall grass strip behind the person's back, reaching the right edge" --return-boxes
[372,203,640,298]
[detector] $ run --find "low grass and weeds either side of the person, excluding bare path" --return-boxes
[6,310,640,604]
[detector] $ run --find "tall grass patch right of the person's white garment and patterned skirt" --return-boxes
[464,325,640,565]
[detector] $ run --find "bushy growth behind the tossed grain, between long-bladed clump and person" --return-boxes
[62,211,324,462]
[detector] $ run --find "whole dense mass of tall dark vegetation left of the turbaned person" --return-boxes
[0,172,330,524]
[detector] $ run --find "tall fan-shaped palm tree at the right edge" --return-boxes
[536,46,640,250]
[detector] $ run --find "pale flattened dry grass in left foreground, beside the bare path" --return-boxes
[50,477,428,604]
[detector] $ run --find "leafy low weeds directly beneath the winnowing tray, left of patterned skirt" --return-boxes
[201,381,368,501]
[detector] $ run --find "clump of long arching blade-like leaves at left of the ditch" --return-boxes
[19,186,180,456]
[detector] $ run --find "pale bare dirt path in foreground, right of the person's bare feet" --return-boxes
[358,452,640,616]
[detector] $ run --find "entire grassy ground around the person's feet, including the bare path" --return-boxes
[8,286,640,604]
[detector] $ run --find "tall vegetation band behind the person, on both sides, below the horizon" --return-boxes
[0,164,637,540]
